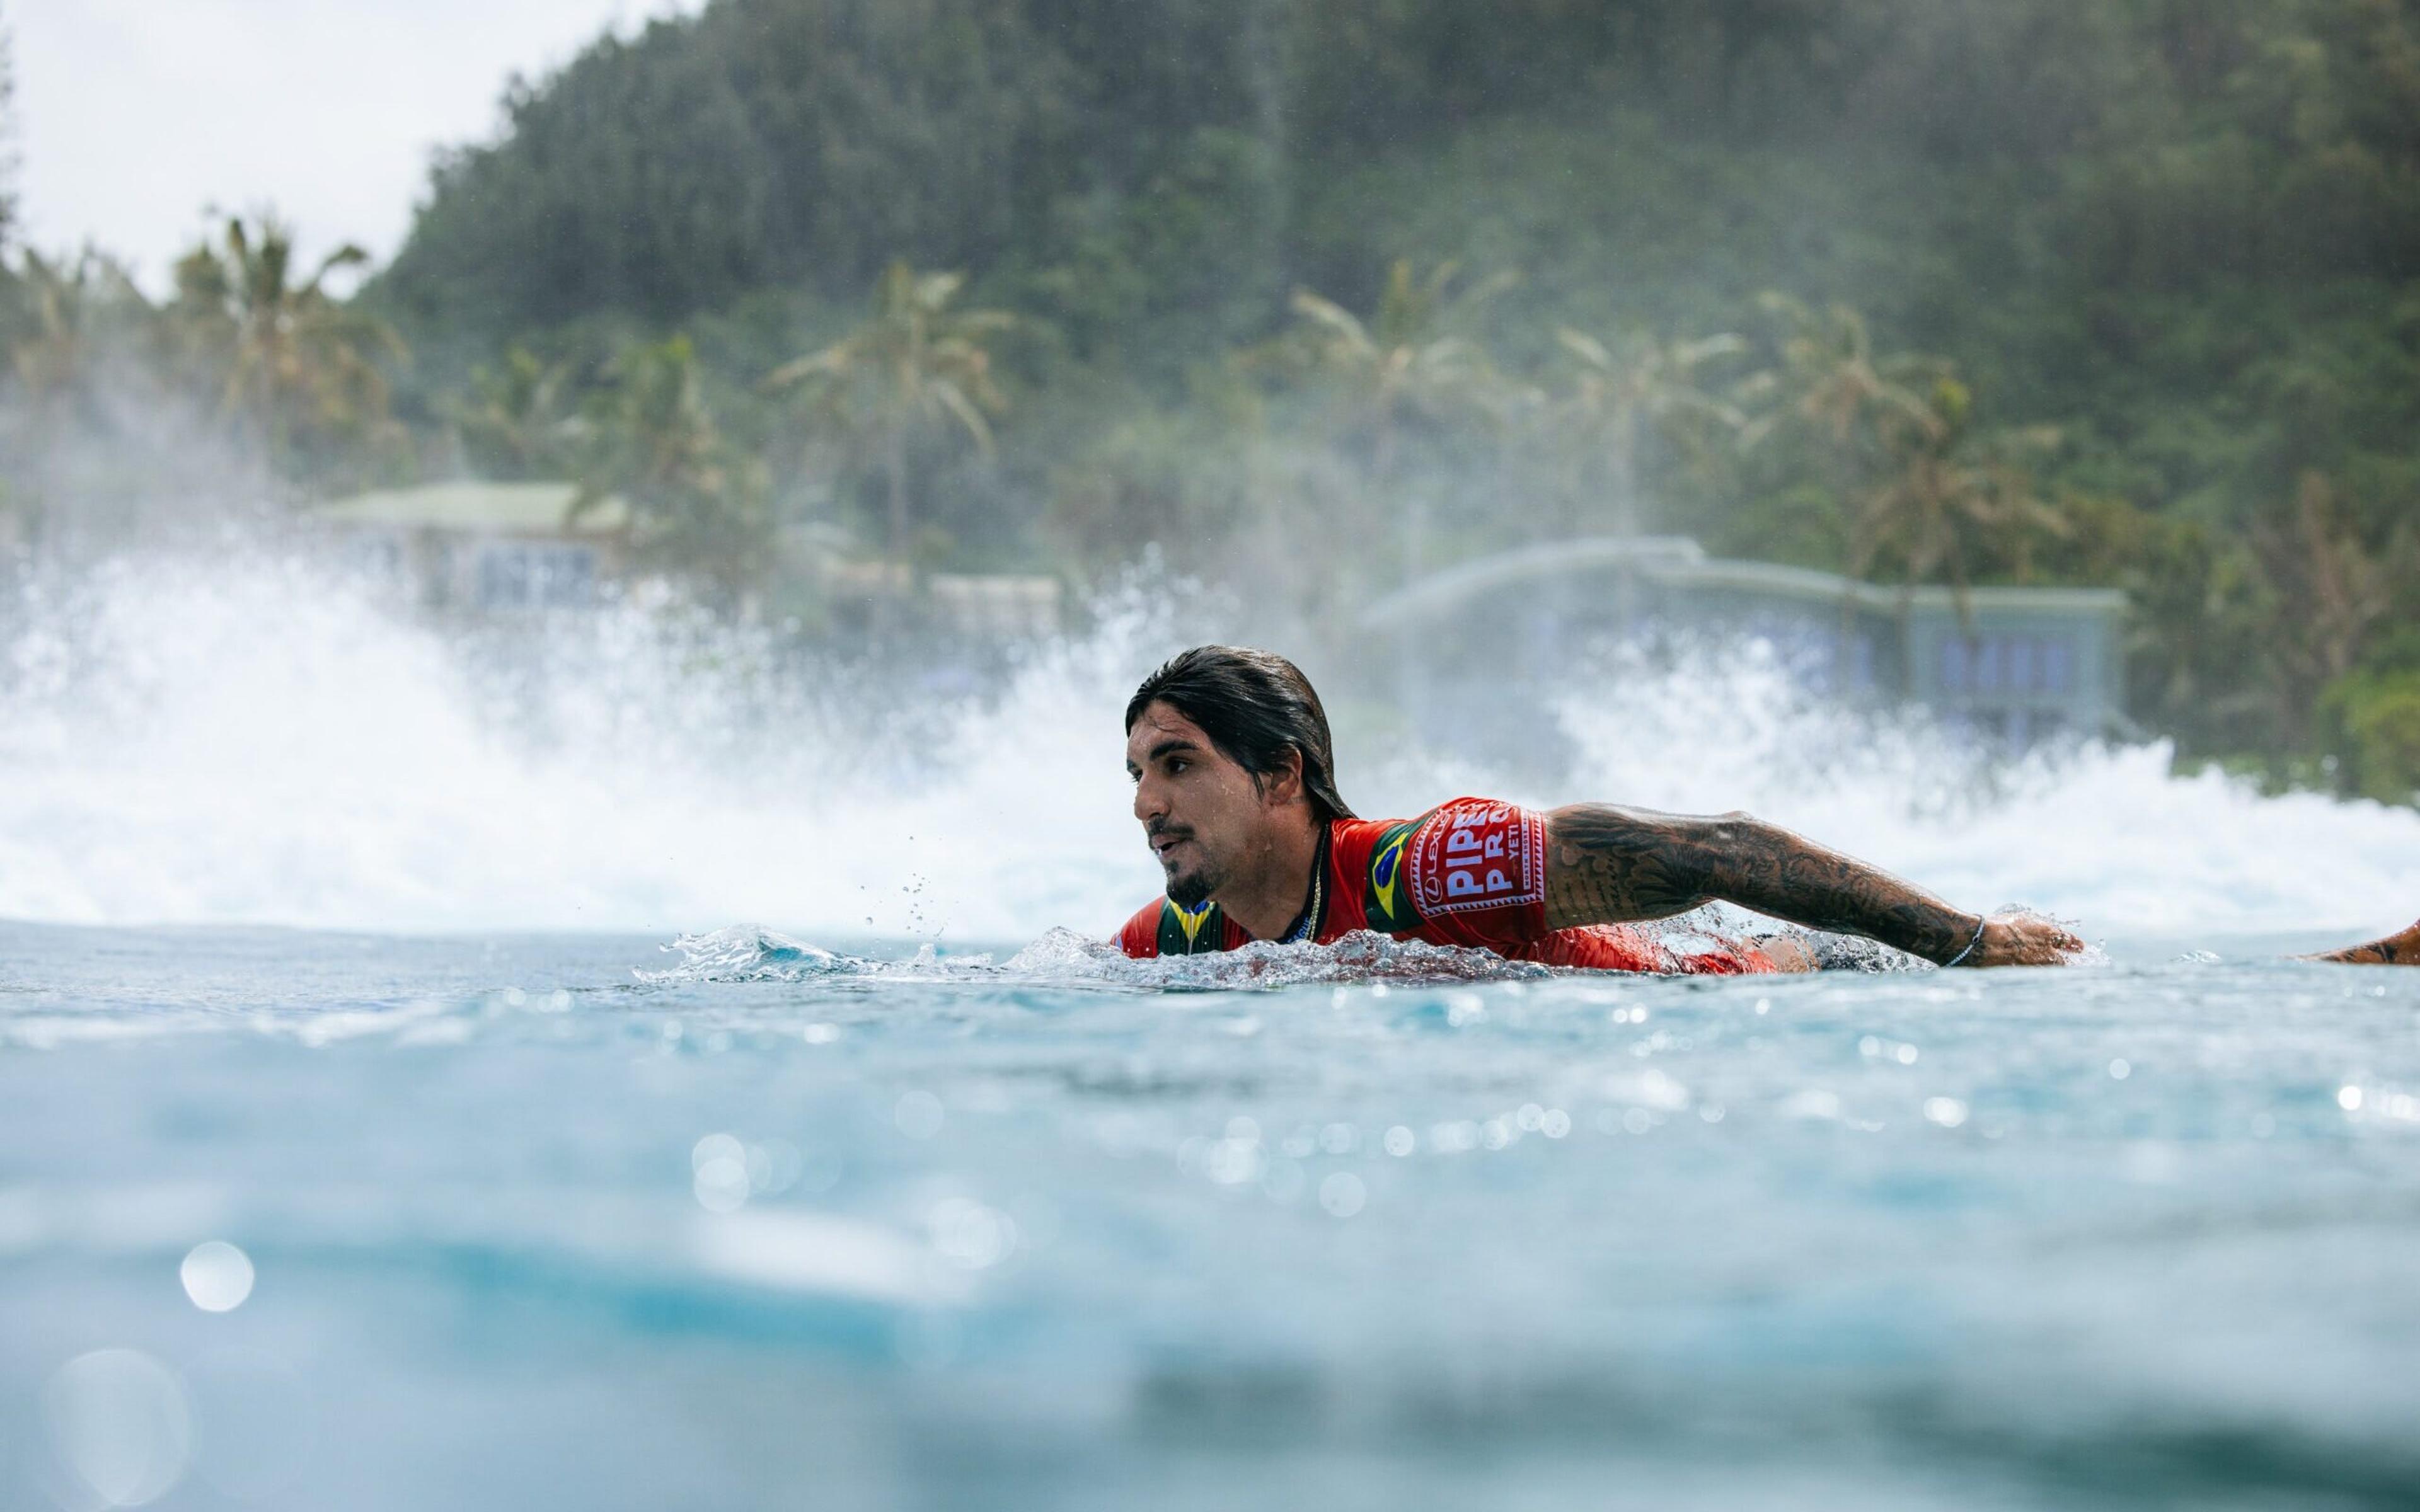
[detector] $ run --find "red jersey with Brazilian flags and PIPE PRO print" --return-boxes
[1118,798,1774,975]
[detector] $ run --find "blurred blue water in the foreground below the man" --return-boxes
[0,924,2420,1512]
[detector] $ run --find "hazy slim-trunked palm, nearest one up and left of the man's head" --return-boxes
[764,261,1019,561]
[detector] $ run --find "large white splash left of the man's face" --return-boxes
[0,549,1173,939]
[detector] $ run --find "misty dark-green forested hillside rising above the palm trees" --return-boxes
[383,0,2420,430]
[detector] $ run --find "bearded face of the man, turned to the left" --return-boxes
[1126,702,1278,907]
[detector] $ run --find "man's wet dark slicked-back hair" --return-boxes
[1126,646,1353,823]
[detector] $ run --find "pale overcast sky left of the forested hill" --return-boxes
[14,0,697,288]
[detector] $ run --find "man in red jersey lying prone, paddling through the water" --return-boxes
[1118,646,2420,975]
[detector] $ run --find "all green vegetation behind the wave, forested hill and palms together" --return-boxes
[0,0,2420,798]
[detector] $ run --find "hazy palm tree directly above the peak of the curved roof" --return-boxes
[1549,326,1747,535]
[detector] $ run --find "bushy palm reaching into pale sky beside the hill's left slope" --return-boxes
[170,215,406,476]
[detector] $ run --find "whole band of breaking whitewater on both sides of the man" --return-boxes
[0,556,2420,941]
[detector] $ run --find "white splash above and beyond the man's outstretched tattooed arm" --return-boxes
[1561,646,2420,941]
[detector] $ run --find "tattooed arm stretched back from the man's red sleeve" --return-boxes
[1547,803,2083,965]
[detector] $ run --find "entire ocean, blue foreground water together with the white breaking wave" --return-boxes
[0,561,2420,1512]
